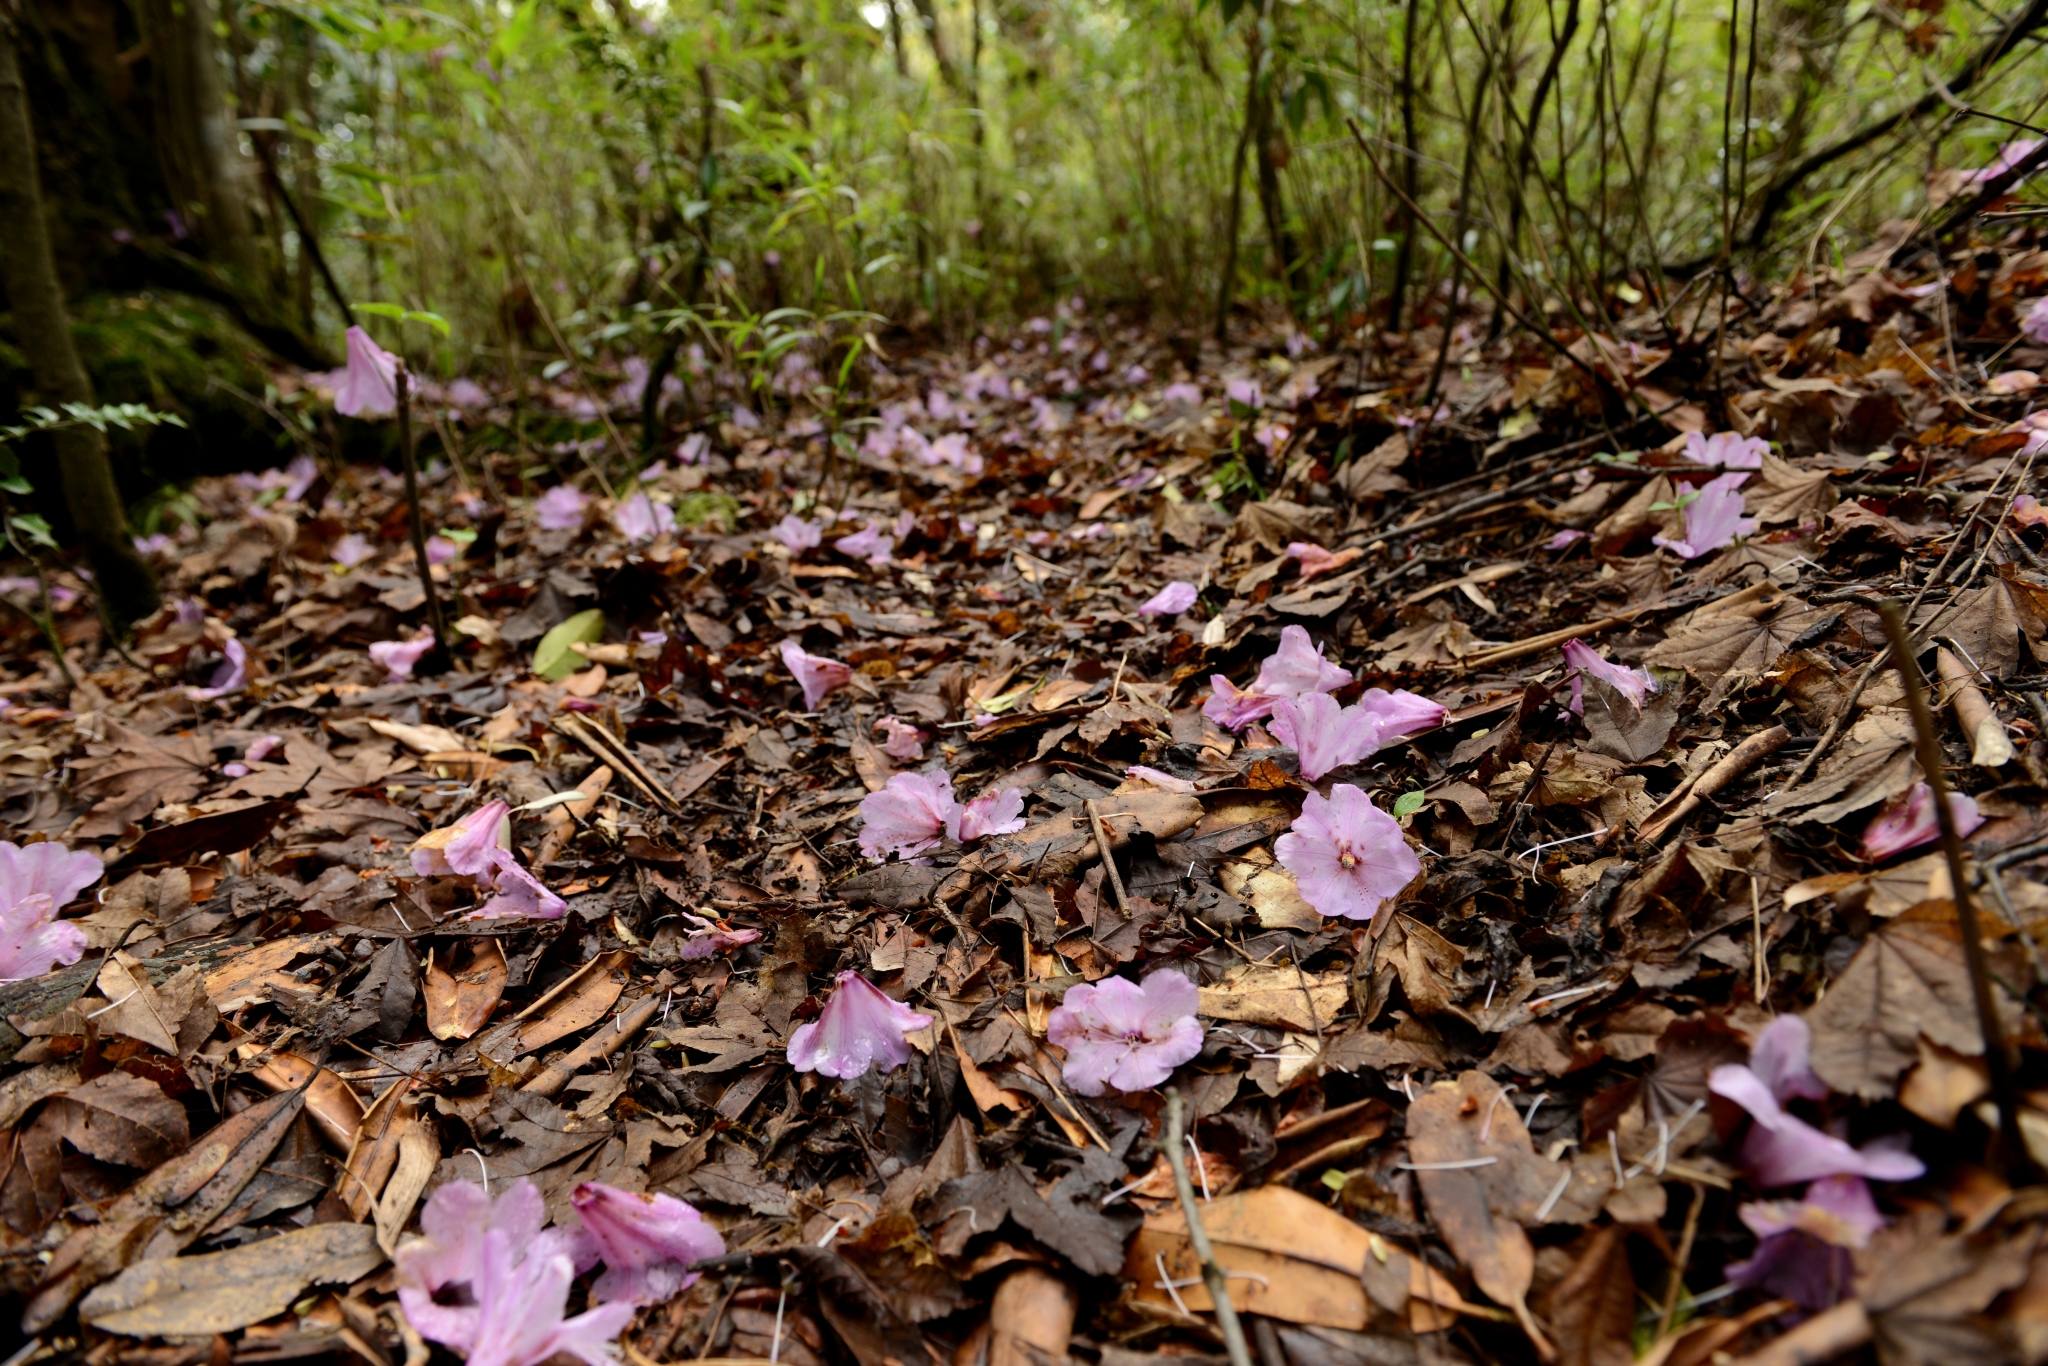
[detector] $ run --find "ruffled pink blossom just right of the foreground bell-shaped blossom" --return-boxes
[1044,971,1202,1096]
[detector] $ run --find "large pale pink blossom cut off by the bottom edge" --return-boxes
[391,1178,633,1366]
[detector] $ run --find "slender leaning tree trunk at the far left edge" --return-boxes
[0,23,158,627]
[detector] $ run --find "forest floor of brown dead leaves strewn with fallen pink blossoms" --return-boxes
[0,214,2048,1366]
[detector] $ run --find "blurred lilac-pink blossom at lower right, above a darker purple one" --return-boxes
[1706,1016,1927,1190]
